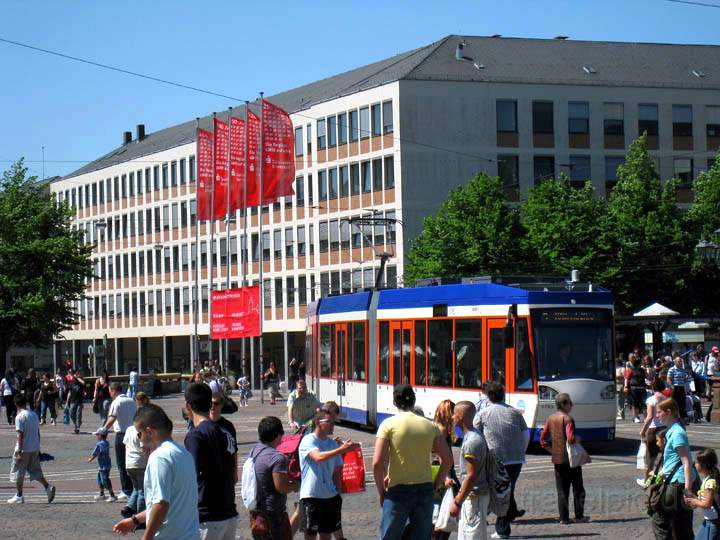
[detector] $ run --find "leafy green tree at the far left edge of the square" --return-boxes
[0,160,92,372]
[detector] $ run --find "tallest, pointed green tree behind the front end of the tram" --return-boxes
[600,136,692,313]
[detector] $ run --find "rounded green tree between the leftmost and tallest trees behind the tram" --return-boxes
[520,175,605,279]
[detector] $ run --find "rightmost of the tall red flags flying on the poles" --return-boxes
[262,101,295,204]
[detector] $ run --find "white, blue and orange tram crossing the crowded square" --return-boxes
[306,276,616,441]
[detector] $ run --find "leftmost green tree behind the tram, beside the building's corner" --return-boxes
[404,173,524,283]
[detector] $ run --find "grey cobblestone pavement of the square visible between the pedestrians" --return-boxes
[0,396,720,540]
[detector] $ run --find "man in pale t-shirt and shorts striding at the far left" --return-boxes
[7,394,55,504]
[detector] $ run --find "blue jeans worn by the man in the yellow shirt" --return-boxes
[380,482,433,540]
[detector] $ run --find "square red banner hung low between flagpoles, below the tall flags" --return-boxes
[210,285,260,339]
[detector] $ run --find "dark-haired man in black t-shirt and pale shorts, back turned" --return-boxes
[185,383,238,540]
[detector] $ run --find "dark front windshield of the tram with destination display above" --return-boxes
[531,308,613,381]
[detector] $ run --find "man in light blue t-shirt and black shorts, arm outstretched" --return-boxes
[299,406,359,540]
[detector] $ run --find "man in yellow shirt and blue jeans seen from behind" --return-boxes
[373,384,453,540]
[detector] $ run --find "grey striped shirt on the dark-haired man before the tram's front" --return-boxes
[473,402,529,465]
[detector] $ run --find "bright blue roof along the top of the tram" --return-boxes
[319,283,613,315]
